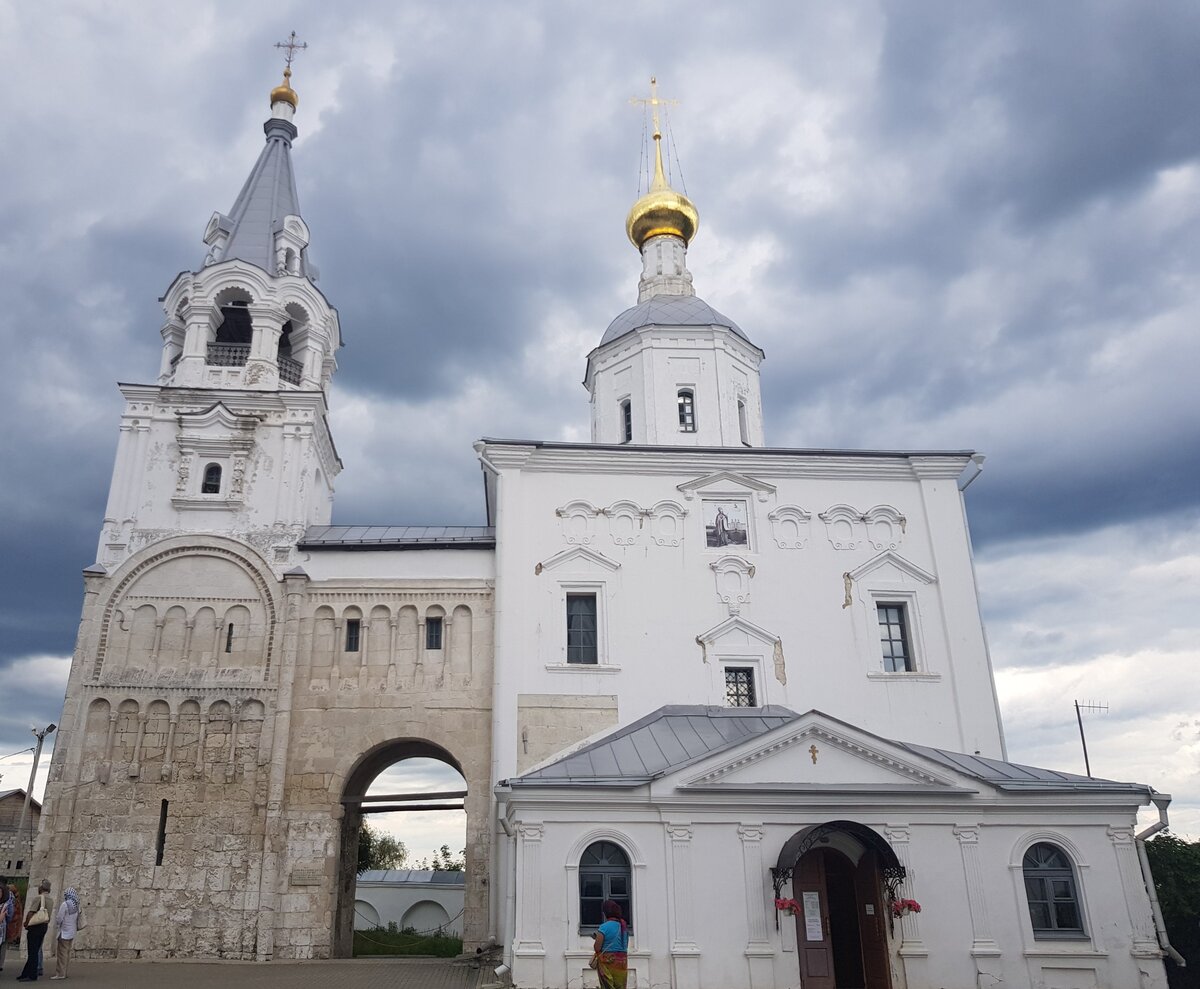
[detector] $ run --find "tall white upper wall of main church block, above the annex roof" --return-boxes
[481,444,1003,780]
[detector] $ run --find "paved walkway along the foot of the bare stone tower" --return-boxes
[23,954,498,989]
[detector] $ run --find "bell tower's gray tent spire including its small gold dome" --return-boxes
[204,92,317,281]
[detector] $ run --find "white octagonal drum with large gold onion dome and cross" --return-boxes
[583,79,763,446]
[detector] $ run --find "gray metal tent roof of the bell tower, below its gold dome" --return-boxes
[211,119,316,277]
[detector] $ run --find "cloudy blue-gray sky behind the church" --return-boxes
[0,0,1200,853]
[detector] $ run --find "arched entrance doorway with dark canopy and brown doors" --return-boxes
[772,821,904,989]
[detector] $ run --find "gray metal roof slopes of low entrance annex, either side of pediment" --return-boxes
[509,705,1150,792]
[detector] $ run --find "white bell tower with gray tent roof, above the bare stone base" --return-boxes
[97,54,342,570]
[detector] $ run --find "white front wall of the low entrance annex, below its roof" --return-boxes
[501,793,1166,989]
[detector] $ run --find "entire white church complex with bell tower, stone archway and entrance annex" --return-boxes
[36,67,1169,989]
